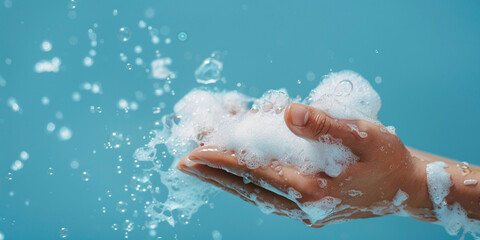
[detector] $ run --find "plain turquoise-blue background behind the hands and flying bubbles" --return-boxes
[0,0,480,240]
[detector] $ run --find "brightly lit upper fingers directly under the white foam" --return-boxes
[182,147,330,202]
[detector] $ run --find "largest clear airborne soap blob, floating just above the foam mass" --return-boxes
[195,52,223,84]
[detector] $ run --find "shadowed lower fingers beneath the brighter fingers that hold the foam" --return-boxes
[178,155,299,215]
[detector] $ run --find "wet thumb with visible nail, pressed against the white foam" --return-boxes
[285,103,369,148]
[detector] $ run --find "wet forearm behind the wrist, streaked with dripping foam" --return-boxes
[407,148,480,221]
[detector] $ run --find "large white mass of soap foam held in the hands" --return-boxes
[135,71,381,225]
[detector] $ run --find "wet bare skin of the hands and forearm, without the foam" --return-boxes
[178,103,480,227]
